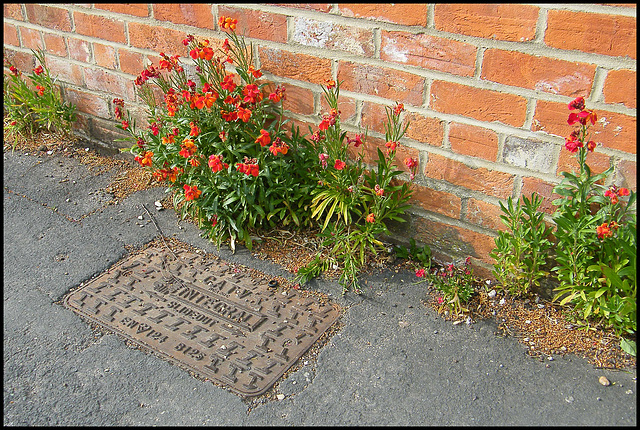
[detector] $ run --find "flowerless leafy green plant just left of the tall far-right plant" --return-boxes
[491,193,551,296]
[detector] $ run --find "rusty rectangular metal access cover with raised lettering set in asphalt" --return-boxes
[64,248,339,396]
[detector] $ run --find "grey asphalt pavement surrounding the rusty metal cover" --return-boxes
[3,152,637,426]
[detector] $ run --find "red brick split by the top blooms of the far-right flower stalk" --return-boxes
[531,101,637,154]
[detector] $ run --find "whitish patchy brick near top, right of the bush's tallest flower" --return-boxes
[291,17,375,57]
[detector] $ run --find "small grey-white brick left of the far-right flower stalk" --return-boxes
[502,136,556,173]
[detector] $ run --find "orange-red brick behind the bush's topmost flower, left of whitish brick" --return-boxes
[221,5,287,43]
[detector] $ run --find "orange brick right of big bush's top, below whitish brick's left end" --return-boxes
[258,47,331,85]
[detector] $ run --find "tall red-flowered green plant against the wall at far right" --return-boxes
[552,97,637,352]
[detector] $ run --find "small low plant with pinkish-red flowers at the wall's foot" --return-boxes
[416,257,475,316]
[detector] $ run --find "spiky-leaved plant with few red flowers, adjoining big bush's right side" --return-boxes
[297,81,417,294]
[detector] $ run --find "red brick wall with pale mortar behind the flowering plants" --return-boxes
[4,3,636,276]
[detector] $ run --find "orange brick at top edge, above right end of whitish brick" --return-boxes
[338,3,427,26]
